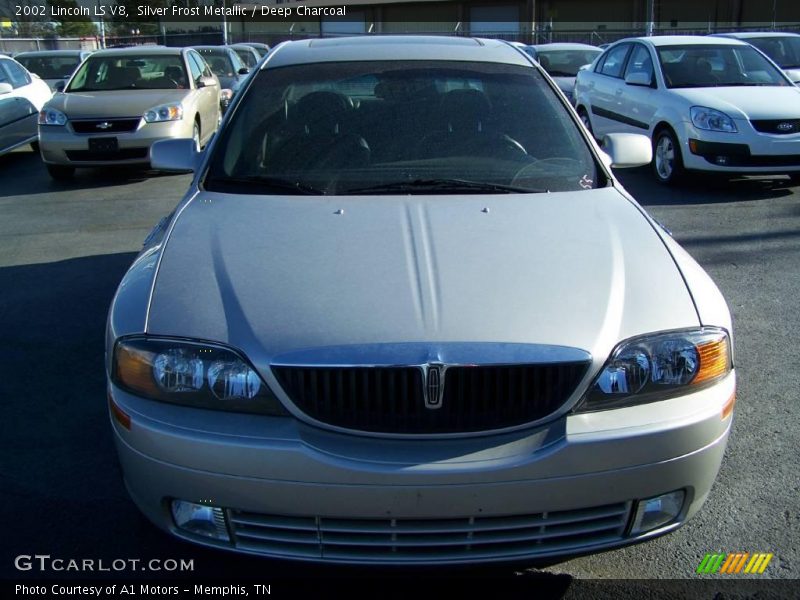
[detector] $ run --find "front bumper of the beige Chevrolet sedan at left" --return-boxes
[39,118,194,167]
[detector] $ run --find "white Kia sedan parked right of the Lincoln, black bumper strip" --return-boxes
[575,36,800,184]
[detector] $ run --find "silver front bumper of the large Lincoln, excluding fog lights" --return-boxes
[110,373,735,564]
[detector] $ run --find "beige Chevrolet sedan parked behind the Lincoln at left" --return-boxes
[39,47,220,179]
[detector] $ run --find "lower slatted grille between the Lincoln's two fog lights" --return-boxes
[228,502,631,563]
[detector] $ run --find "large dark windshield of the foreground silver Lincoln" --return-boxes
[204,61,600,195]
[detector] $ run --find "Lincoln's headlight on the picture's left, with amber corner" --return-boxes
[111,338,289,416]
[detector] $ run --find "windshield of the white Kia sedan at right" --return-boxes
[658,44,790,88]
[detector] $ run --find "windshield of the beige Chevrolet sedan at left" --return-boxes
[66,54,188,92]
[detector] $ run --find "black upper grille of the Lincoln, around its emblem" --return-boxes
[272,362,588,434]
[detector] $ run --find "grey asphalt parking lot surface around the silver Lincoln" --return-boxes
[0,147,800,578]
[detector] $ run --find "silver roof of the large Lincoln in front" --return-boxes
[261,35,531,69]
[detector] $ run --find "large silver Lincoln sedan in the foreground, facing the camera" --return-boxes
[106,36,735,565]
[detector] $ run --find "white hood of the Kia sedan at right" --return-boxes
[672,85,800,119]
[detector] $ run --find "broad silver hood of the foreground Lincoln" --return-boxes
[147,188,699,364]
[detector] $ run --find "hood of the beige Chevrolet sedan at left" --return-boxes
[48,90,189,119]
